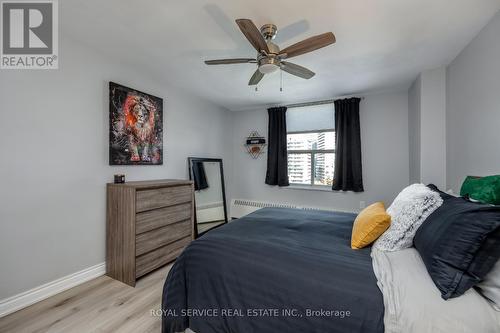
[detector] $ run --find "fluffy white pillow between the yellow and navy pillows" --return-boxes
[374,184,443,251]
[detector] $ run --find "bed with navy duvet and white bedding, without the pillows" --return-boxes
[162,208,500,333]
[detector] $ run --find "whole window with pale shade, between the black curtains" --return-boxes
[287,104,335,186]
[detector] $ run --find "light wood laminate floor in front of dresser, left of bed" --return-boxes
[0,265,171,333]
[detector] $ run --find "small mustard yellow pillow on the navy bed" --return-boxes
[351,202,391,249]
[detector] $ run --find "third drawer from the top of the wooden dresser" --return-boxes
[135,220,192,256]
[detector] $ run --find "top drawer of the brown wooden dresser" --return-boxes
[136,185,193,212]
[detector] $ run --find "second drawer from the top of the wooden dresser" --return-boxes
[135,203,192,235]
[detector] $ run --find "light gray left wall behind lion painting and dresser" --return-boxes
[0,35,232,299]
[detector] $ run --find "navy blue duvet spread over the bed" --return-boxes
[162,208,384,333]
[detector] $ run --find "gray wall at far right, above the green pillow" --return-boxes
[446,12,500,191]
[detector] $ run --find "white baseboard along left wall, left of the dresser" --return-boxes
[0,263,106,318]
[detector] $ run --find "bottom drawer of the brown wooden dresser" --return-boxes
[135,237,191,277]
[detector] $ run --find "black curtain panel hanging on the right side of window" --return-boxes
[332,98,364,192]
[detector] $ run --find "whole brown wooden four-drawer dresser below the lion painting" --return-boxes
[106,179,194,286]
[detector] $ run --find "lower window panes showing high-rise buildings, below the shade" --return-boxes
[287,131,335,186]
